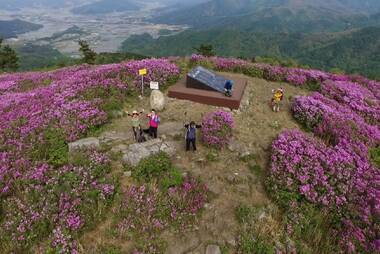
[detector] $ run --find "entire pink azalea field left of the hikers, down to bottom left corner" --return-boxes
[0,59,179,253]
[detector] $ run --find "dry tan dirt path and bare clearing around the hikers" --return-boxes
[82,73,307,254]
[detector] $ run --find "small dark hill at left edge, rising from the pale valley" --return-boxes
[0,19,43,39]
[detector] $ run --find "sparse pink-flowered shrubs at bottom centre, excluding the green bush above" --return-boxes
[113,177,207,254]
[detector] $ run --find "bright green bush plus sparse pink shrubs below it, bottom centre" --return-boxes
[112,153,208,254]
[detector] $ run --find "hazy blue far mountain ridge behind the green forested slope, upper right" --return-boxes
[152,0,380,32]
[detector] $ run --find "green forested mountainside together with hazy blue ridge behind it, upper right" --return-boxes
[133,0,380,79]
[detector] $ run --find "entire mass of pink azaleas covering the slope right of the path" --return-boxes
[270,76,380,253]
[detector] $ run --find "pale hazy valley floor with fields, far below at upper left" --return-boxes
[0,3,186,58]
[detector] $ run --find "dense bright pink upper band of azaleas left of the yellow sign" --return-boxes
[0,59,179,193]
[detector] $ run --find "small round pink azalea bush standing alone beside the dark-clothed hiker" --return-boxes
[202,111,233,149]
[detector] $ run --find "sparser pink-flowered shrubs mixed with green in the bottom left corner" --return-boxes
[0,151,115,253]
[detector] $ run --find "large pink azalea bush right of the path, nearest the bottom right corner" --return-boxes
[271,131,379,252]
